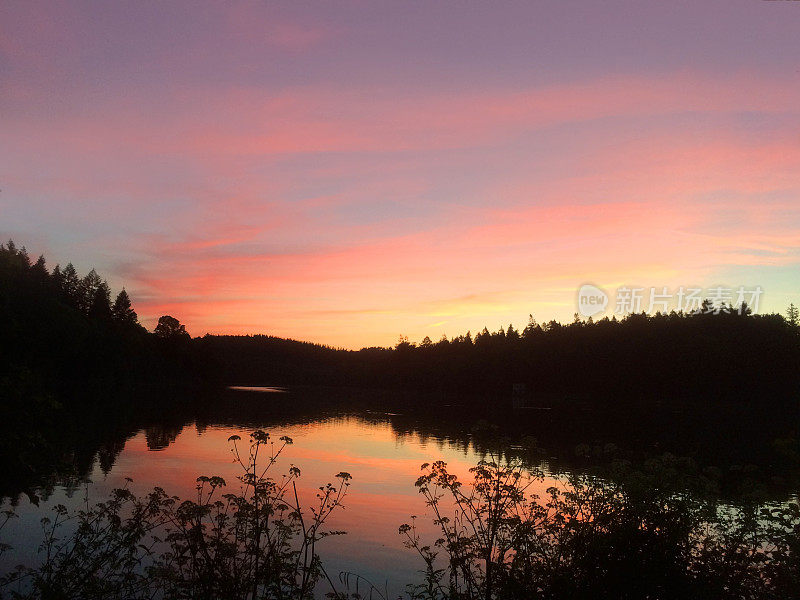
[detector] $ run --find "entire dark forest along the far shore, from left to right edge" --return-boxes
[0,242,800,406]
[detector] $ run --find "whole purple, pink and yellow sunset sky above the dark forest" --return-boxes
[0,0,800,348]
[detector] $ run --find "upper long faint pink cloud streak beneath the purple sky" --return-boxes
[9,73,798,160]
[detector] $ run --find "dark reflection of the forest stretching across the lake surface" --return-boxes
[0,386,798,503]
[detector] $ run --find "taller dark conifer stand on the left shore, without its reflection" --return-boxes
[0,241,198,392]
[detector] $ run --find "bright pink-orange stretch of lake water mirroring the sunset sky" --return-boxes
[2,389,560,597]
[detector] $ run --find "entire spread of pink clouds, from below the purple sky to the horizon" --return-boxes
[4,62,800,346]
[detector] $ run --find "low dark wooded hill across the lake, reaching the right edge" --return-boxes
[195,307,800,406]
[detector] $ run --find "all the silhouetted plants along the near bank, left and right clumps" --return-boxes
[0,431,800,600]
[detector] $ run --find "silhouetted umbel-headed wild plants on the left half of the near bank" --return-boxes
[0,430,351,600]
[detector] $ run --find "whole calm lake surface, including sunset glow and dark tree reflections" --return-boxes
[0,386,796,597]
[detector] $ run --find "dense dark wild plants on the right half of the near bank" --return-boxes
[399,455,800,600]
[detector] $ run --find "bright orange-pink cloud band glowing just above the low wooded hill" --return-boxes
[122,182,800,343]
